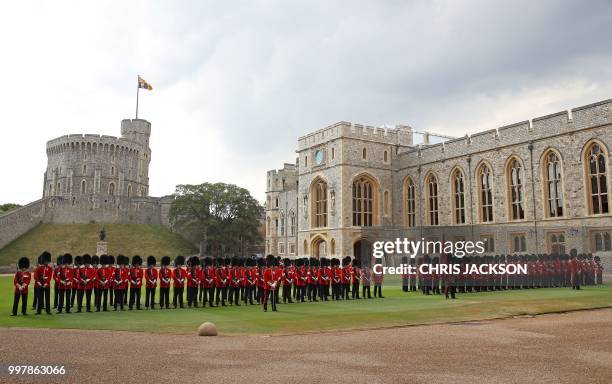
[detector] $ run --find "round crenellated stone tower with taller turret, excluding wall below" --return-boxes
[43,119,151,200]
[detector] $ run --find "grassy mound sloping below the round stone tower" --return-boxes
[0,224,197,265]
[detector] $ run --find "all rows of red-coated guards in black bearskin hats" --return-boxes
[12,250,603,316]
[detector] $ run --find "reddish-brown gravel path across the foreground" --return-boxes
[0,309,612,384]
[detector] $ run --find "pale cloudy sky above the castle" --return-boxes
[0,0,612,204]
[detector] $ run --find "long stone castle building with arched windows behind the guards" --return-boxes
[266,100,612,270]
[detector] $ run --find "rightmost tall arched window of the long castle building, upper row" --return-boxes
[585,143,609,215]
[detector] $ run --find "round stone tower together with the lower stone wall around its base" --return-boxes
[0,119,172,248]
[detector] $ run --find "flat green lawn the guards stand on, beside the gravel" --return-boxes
[0,276,612,335]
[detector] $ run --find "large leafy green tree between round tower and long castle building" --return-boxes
[170,183,263,256]
